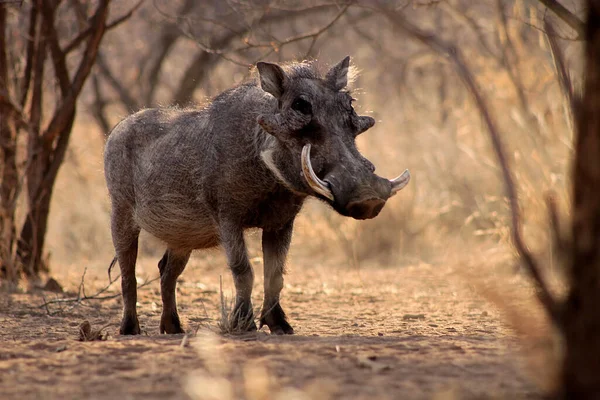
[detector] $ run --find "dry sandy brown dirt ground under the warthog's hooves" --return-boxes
[0,260,546,400]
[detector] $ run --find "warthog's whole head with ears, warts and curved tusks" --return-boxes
[257,57,410,219]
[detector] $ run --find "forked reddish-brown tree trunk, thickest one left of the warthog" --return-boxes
[17,0,109,277]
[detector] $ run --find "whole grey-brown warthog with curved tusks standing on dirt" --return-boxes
[104,57,410,335]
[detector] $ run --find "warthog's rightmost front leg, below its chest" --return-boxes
[260,222,294,335]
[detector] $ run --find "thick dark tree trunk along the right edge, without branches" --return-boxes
[562,0,600,399]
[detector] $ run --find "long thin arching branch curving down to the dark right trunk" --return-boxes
[382,5,562,326]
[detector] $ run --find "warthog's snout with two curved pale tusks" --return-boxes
[302,144,410,219]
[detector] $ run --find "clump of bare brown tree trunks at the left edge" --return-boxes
[0,0,110,282]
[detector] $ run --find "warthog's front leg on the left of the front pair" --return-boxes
[220,221,256,331]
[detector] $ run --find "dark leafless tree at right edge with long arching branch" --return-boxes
[382,0,600,399]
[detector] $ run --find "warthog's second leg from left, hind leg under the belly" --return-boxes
[158,249,191,333]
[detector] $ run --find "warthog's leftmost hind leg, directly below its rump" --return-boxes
[111,204,141,335]
